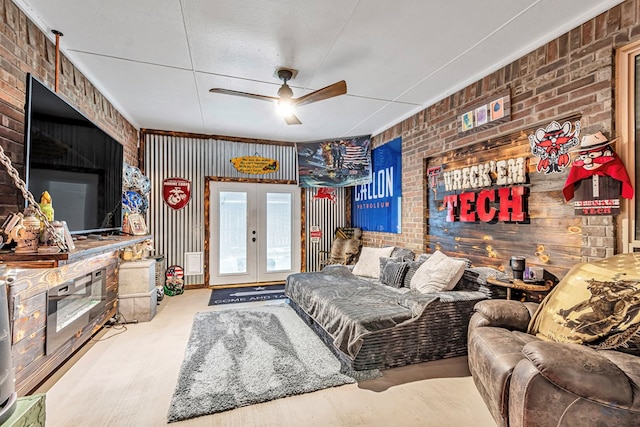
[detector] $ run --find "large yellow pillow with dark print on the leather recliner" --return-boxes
[529,253,640,344]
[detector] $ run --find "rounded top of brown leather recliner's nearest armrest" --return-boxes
[522,341,640,408]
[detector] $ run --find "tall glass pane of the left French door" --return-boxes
[218,191,247,274]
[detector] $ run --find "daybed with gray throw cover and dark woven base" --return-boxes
[285,251,505,371]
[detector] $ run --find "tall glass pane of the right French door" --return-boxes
[266,193,292,272]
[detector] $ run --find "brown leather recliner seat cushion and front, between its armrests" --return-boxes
[469,327,537,417]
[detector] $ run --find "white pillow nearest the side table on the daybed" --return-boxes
[410,251,467,294]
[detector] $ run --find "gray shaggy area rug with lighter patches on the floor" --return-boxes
[167,304,355,422]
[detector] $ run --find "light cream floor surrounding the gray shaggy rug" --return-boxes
[36,289,495,427]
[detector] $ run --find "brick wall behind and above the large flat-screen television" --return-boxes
[0,0,138,219]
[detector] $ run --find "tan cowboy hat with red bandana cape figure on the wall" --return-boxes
[562,132,633,201]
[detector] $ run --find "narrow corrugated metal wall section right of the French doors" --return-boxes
[304,188,348,271]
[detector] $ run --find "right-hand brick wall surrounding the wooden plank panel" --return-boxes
[364,0,640,260]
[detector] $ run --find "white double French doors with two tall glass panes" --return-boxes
[208,181,301,286]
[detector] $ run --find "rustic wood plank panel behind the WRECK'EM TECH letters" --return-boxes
[424,116,582,277]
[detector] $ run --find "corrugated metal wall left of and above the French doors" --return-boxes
[144,133,297,285]
